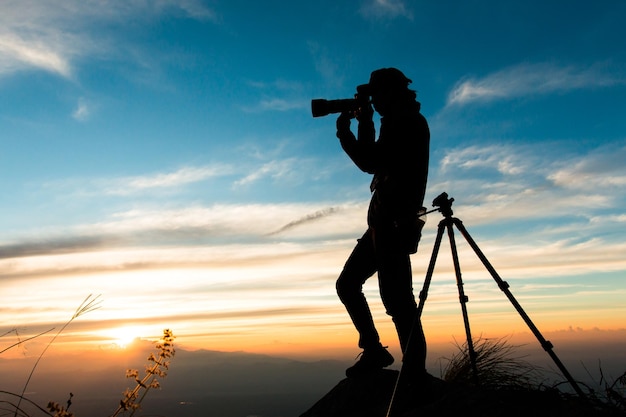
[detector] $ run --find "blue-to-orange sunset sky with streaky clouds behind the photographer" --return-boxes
[0,0,626,368]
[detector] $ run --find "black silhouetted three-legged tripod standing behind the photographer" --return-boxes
[387,193,586,417]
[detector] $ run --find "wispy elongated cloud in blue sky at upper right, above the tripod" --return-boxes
[447,63,626,106]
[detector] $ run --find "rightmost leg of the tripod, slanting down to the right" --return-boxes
[450,218,586,398]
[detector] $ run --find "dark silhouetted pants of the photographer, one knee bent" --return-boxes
[337,228,426,370]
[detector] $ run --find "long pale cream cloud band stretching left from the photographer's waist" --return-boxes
[0,199,367,279]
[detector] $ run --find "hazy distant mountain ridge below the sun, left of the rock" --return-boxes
[0,341,347,417]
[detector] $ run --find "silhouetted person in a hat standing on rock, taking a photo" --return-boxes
[337,68,430,378]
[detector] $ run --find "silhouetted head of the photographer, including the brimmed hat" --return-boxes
[357,68,415,116]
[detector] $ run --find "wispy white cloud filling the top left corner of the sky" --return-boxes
[0,0,217,78]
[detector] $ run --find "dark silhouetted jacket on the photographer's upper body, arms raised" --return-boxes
[338,101,430,253]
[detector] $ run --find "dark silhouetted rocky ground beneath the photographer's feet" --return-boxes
[300,370,626,417]
